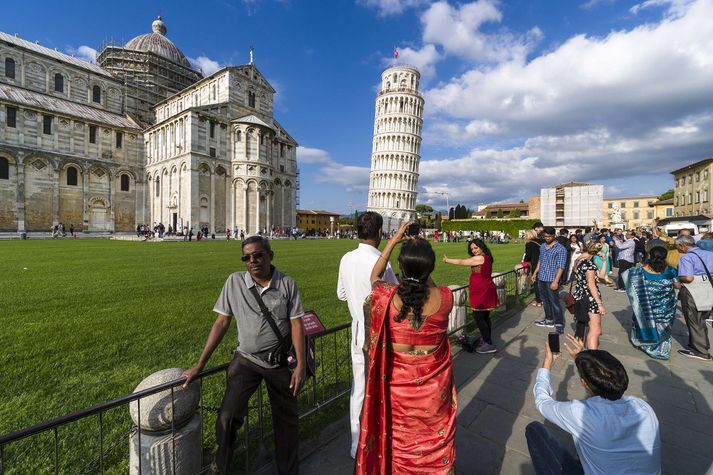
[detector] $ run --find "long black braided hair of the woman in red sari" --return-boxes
[394,238,436,328]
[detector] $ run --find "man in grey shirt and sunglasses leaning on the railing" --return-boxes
[184,236,306,475]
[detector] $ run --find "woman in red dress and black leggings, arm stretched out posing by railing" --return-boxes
[443,239,499,353]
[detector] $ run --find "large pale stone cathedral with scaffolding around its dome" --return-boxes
[0,17,298,234]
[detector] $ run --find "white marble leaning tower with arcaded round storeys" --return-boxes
[367,66,424,231]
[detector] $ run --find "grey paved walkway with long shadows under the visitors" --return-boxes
[301,288,713,475]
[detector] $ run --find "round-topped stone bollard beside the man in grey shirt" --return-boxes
[129,368,203,475]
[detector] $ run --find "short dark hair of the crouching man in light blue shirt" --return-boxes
[574,350,629,401]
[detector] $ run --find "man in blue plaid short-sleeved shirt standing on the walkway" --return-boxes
[532,227,567,334]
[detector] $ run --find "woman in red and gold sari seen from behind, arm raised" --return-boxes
[356,222,456,475]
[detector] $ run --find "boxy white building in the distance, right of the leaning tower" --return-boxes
[540,182,604,228]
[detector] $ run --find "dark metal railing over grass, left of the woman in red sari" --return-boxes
[0,323,352,474]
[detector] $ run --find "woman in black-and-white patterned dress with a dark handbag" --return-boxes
[572,240,606,350]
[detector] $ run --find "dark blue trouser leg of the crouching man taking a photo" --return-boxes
[525,422,584,475]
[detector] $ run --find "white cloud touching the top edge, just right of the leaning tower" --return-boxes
[421,0,542,63]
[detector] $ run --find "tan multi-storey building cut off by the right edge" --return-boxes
[665,157,713,231]
